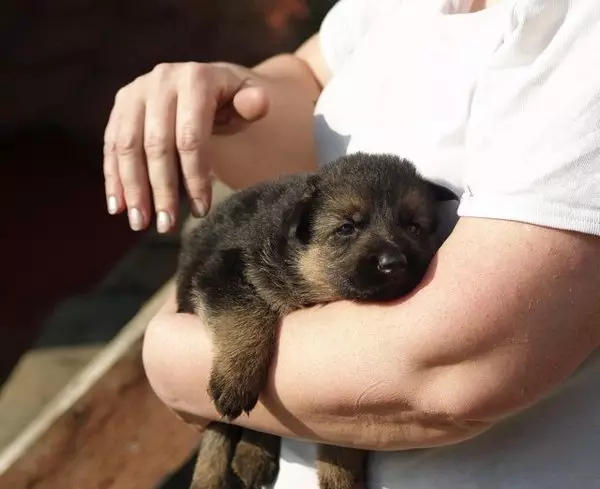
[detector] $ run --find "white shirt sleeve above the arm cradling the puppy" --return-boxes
[458,0,600,235]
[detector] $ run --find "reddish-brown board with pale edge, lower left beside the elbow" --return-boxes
[0,284,198,489]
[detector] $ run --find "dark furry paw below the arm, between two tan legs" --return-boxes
[231,440,279,489]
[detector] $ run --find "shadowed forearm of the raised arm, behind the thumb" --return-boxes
[209,54,321,188]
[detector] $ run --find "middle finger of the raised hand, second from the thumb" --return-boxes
[144,79,179,233]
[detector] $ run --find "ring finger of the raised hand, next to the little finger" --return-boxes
[117,92,150,231]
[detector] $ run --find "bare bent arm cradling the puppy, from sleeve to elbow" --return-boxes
[144,218,600,450]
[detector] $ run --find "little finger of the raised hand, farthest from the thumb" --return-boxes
[103,99,125,215]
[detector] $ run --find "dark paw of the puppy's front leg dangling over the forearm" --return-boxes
[209,368,262,420]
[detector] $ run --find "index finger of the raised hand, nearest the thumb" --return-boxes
[176,65,218,216]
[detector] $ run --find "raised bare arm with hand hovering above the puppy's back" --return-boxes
[104,34,331,232]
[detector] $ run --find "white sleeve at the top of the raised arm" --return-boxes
[319,0,402,74]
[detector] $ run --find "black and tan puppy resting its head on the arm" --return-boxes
[177,153,454,489]
